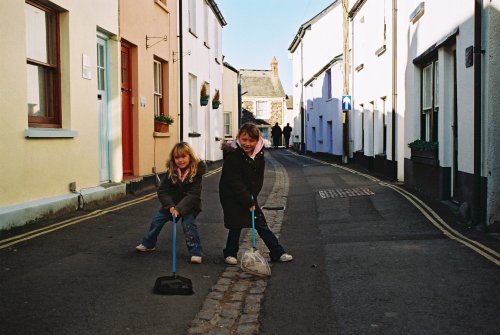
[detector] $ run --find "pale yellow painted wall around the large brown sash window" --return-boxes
[0,0,118,206]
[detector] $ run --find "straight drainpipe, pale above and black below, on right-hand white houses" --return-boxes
[391,0,398,181]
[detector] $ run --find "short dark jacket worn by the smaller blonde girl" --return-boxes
[157,162,206,216]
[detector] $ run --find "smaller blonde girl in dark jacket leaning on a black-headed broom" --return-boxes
[136,142,206,264]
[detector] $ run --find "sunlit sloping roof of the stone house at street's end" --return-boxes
[240,69,285,98]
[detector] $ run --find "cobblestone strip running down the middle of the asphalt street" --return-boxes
[187,155,289,335]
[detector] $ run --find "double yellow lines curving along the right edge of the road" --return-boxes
[290,155,500,265]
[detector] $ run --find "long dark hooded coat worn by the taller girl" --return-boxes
[219,138,265,229]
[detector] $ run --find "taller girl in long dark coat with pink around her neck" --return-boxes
[219,123,293,265]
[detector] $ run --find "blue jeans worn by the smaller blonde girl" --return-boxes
[142,212,203,256]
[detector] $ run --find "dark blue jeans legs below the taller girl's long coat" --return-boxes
[224,217,285,262]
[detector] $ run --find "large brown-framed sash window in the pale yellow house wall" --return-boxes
[26,1,61,128]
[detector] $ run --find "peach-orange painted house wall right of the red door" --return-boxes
[120,0,179,176]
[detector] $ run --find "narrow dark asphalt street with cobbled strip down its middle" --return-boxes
[0,149,500,334]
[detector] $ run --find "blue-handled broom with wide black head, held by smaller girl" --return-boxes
[154,216,194,295]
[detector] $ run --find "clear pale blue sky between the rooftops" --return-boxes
[216,0,333,94]
